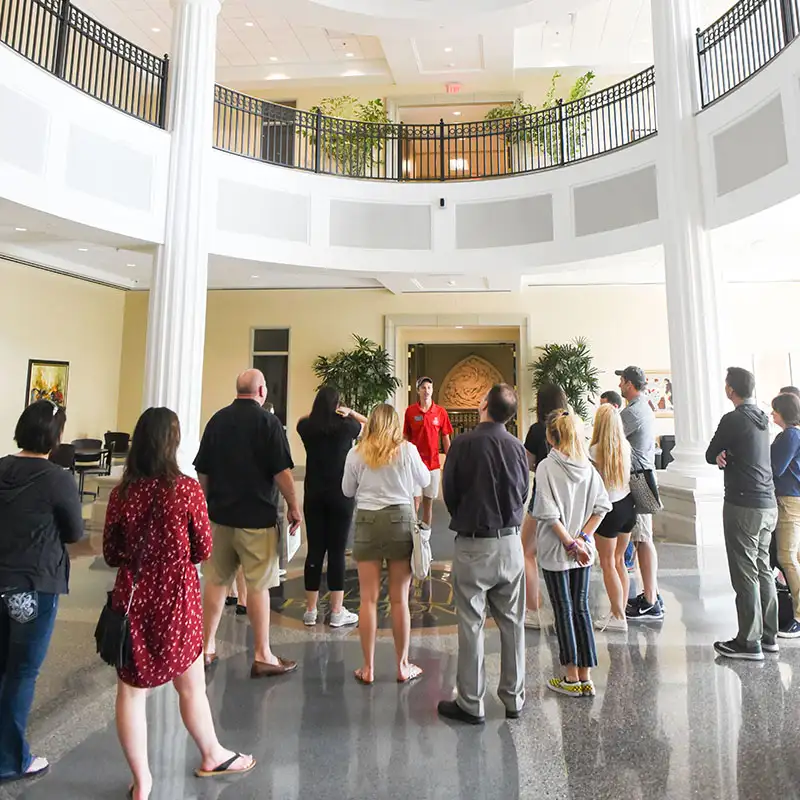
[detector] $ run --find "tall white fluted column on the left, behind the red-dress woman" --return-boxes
[144,0,220,473]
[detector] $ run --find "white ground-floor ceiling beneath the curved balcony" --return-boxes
[0,199,800,294]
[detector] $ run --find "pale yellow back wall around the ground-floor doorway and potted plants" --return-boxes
[119,286,669,464]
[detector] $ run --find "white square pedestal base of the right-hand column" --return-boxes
[653,464,724,548]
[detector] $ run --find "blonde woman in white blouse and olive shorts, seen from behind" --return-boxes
[342,403,431,685]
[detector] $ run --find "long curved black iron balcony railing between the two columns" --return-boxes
[214,68,657,181]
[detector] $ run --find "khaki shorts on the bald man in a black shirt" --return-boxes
[203,522,280,592]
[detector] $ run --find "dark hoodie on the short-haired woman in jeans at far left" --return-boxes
[0,456,83,594]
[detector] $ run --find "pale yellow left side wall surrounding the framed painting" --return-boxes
[0,259,125,454]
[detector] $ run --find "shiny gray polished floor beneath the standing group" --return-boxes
[0,516,800,800]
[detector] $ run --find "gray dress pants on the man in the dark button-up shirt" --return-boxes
[453,535,525,716]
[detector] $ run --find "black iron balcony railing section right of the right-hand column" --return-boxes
[697,0,800,108]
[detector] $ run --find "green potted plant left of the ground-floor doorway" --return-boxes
[313,333,400,414]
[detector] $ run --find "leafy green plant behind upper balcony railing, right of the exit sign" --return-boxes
[484,71,596,160]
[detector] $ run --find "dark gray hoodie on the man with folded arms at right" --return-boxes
[706,403,776,508]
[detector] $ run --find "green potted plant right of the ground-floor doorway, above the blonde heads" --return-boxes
[529,337,600,419]
